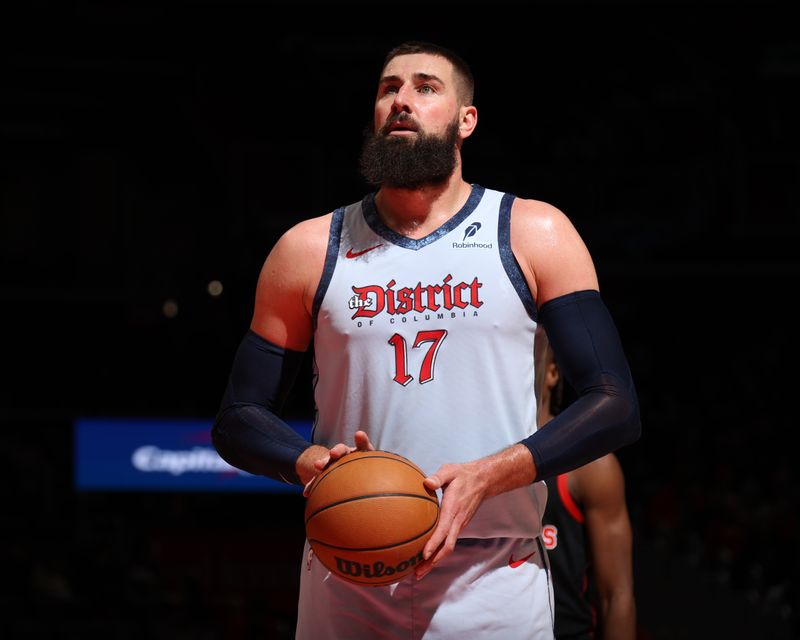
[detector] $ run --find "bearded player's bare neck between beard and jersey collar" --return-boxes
[375,171,472,238]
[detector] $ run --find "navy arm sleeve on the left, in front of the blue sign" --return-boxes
[211,330,311,484]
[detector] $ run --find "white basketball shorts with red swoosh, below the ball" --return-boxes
[296,538,553,640]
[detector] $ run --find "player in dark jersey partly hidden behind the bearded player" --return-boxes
[535,326,636,640]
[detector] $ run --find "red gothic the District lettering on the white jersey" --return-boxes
[348,273,483,319]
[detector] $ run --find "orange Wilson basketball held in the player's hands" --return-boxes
[305,451,439,586]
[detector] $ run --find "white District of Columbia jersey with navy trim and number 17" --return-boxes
[313,185,547,538]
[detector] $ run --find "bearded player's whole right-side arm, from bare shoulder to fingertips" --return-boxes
[417,200,639,577]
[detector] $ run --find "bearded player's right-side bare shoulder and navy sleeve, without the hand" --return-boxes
[511,200,641,480]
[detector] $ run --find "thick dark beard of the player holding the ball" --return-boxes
[360,122,458,189]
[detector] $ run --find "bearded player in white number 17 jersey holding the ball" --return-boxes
[213,43,640,640]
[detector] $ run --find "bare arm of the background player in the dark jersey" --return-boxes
[569,454,636,640]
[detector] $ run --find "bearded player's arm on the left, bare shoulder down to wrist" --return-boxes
[212,216,340,484]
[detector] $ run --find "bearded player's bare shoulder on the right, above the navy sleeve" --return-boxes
[511,198,599,307]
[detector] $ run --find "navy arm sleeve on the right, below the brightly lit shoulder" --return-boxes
[521,290,641,480]
